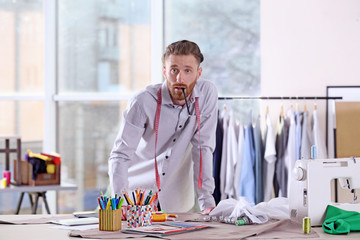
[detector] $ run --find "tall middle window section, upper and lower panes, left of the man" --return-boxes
[58,0,151,211]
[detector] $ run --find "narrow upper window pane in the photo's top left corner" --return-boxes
[0,0,44,93]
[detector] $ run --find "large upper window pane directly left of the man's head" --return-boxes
[58,0,150,93]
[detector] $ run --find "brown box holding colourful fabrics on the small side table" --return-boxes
[14,160,61,186]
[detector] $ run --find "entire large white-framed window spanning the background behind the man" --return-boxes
[0,0,260,213]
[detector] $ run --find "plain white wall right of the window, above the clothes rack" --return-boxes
[261,0,360,154]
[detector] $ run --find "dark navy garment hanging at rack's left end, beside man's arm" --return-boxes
[213,118,223,204]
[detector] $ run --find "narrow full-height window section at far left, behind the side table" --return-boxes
[0,0,44,213]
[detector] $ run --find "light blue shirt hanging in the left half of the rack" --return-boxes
[240,111,255,204]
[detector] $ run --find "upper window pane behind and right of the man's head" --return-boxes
[164,0,260,115]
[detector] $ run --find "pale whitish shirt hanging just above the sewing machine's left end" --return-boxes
[280,109,297,197]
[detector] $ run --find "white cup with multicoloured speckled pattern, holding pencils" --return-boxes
[127,205,152,228]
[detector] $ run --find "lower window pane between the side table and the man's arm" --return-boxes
[59,101,127,212]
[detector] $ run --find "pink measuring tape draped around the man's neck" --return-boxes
[155,88,202,198]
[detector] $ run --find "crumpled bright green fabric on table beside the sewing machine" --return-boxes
[322,205,360,234]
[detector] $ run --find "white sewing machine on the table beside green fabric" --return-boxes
[289,158,360,226]
